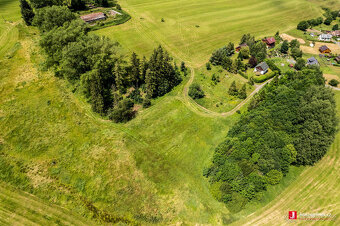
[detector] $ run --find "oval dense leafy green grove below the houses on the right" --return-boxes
[204,68,337,211]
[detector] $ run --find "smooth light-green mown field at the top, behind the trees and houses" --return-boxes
[97,0,320,67]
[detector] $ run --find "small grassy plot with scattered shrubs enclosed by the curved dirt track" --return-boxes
[194,66,254,113]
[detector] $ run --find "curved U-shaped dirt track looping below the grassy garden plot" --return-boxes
[181,68,273,117]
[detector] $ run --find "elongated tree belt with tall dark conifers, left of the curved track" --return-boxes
[34,6,185,122]
